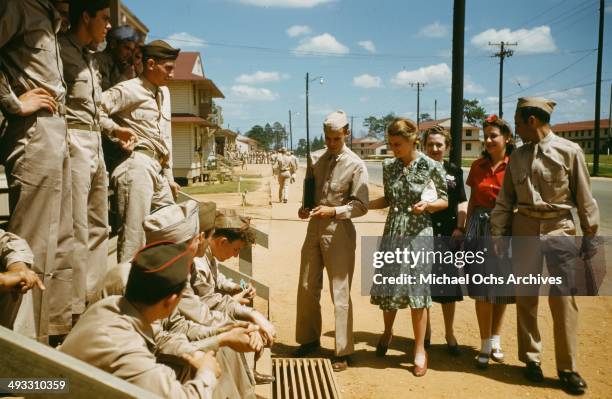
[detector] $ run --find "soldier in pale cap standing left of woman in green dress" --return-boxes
[295,111,368,371]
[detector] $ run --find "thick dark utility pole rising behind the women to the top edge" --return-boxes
[450,0,465,166]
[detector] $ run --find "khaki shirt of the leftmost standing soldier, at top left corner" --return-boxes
[0,0,66,114]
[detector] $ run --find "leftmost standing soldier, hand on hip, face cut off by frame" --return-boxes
[0,0,73,342]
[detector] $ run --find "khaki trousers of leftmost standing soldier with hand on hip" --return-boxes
[0,111,73,343]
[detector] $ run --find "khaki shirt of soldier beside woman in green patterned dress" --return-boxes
[311,146,368,219]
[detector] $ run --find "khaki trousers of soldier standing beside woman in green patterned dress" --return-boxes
[295,218,356,356]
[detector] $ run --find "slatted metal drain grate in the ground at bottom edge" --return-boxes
[272,358,341,399]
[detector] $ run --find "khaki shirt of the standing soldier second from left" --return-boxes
[59,33,113,130]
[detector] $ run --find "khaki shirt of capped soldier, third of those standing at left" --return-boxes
[102,76,171,160]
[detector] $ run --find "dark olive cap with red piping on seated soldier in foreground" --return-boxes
[126,241,192,293]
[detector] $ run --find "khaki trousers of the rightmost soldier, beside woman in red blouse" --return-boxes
[512,213,578,371]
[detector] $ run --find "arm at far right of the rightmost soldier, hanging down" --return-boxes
[569,149,599,236]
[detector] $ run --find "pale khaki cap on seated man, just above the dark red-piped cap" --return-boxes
[142,200,200,243]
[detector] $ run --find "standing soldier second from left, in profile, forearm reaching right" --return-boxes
[60,0,135,316]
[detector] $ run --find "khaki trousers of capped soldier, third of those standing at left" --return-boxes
[111,152,174,263]
